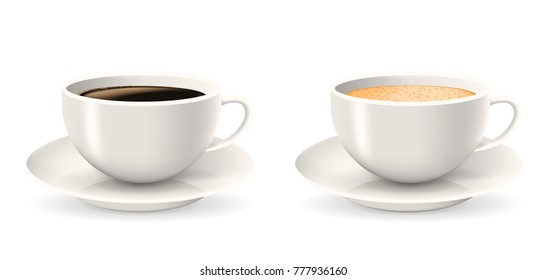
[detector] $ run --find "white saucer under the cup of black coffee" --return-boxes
[27,137,253,211]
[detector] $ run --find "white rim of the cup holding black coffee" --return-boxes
[62,73,220,107]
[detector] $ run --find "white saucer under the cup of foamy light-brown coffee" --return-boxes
[296,137,522,212]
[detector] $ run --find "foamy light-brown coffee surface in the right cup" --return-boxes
[347,85,475,102]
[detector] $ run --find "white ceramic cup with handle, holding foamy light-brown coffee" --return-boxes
[331,75,518,183]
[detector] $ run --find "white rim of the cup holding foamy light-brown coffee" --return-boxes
[331,72,489,107]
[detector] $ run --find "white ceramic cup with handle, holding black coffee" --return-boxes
[62,75,250,183]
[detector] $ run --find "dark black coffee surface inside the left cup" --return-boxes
[80,86,205,101]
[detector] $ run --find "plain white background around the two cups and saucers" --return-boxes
[0,0,547,279]
